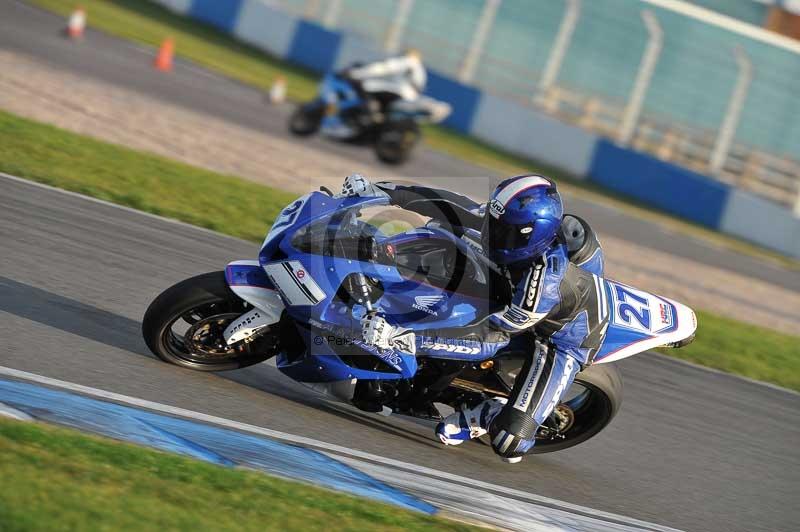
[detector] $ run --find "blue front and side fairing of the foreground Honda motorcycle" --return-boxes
[260,192,504,382]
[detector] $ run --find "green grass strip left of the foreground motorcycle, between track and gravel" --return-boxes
[0,111,296,241]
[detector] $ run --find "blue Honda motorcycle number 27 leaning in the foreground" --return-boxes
[142,189,696,453]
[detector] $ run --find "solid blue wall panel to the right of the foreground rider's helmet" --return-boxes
[589,140,730,229]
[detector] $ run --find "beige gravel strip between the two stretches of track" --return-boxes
[0,51,800,333]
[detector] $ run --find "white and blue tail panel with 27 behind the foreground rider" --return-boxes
[594,280,697,364]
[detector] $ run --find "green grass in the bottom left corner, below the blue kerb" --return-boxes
[0,418,478,532]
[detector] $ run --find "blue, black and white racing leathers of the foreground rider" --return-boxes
[376,183,608,459]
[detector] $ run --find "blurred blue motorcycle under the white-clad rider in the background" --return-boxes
[289,72,451,164]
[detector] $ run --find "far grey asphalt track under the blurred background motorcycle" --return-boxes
[0,0,800,291]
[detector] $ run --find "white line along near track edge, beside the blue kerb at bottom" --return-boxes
[0,366,675,532]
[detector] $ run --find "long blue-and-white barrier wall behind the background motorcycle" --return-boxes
[153,0,800,257]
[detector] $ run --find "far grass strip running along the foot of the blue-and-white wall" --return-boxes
[28,0,800,270]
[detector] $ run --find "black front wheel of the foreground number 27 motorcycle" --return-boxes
[142,271,278,371]
